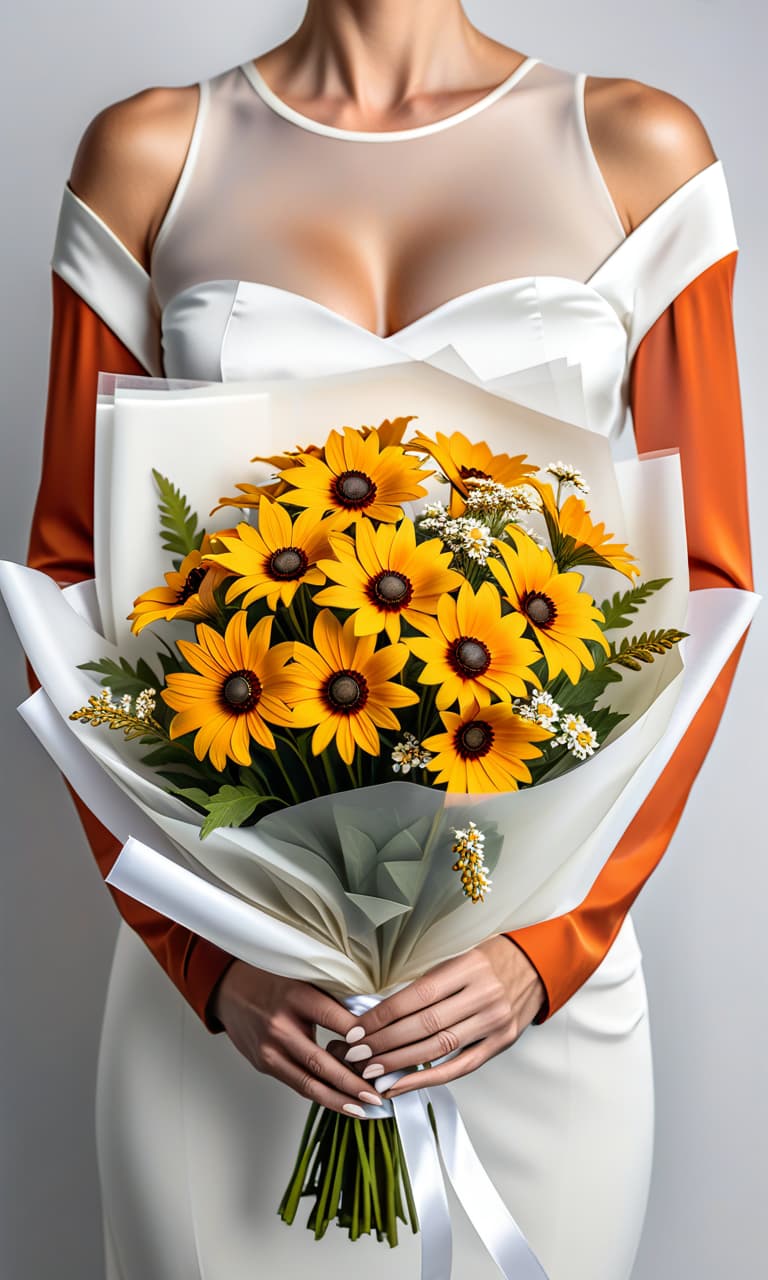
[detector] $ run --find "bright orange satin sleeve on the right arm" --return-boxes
[508,251,753,1023]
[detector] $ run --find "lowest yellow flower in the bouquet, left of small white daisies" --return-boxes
[424,703,552,795]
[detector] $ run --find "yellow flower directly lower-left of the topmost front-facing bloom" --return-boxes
[200,498,338,609]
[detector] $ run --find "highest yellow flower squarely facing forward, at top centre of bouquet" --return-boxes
[279,426,429,529]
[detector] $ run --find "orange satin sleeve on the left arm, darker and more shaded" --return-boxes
[27,273,233,1032]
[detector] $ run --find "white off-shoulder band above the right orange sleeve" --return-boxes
[589,160,739,361]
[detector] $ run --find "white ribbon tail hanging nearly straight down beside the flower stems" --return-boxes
[392,1089,453,1280]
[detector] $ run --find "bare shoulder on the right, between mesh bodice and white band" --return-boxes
[584,76,717,230]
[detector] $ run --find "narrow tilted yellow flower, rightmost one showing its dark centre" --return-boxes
[488,525,608,685]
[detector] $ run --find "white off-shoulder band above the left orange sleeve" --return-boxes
[51,187,163,376]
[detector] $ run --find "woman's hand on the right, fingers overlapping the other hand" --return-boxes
[329,936,547,1098]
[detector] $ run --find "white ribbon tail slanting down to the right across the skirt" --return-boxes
[430,1085,547,1280]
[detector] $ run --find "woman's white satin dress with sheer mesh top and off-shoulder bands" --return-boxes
[52,49,736,1280]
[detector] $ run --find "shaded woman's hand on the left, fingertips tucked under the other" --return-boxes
[211,960,381,1117]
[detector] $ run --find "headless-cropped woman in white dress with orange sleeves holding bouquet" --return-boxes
[29,0,751,1280]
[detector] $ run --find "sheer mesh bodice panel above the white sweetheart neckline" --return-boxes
[151,58,625,335]
